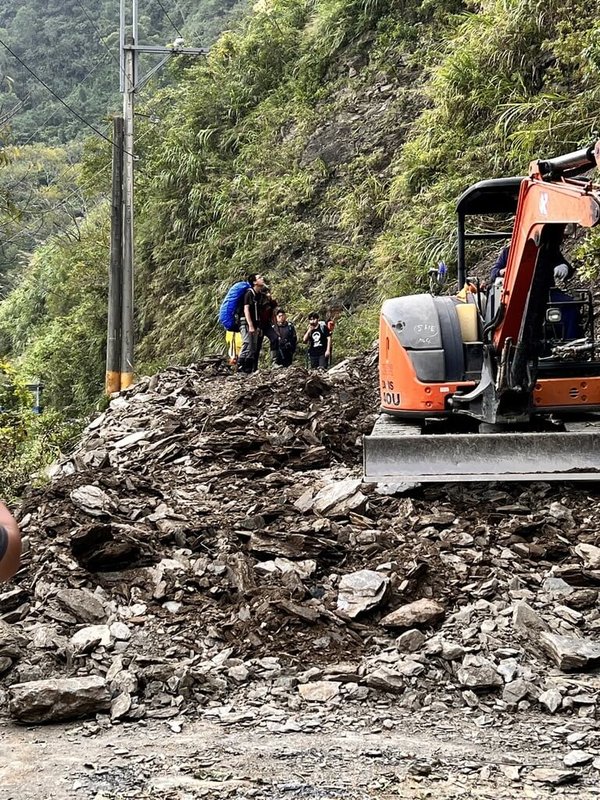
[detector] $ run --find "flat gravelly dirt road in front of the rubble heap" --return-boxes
[0,709,600,800]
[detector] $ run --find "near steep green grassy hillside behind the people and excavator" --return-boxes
[0,0,600,410]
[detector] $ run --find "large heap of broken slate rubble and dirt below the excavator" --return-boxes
[0,354,600,736]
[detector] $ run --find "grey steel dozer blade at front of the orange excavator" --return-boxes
[363,414,600,483]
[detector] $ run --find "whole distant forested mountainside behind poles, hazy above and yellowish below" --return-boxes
[0,0,246,294]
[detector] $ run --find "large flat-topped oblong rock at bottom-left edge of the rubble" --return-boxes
[9,675,110,722]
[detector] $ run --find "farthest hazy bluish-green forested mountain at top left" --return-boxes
[0,0,245,144]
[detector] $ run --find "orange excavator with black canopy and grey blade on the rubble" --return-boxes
[364,143,600,483]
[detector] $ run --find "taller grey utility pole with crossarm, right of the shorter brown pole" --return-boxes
[113,0,208,391]
